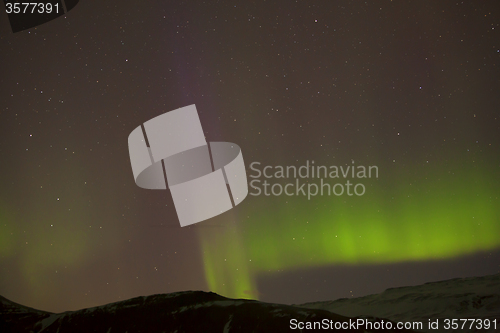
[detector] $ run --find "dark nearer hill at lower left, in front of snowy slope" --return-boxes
[0,291,411,333]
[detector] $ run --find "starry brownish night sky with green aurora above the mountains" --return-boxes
[0,0,500,311]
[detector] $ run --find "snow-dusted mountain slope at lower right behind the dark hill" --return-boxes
[300,274,500,332]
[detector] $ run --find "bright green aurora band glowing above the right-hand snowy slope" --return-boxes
[200,163,500,299]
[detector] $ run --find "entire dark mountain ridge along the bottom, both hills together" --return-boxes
[0,274,500,333]
